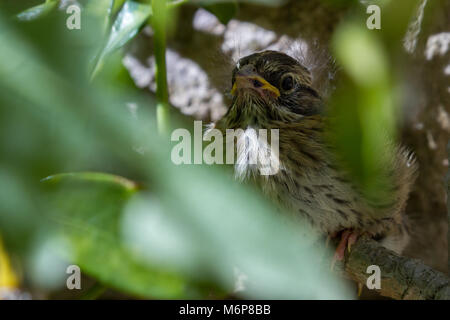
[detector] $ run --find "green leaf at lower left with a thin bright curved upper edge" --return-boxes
[43,172,203,299]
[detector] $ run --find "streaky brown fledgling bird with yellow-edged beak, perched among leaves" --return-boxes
[213,51,417,260]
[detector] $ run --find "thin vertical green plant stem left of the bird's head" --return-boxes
[152,0,170,134]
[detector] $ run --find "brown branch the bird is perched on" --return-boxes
[336,237,450,300]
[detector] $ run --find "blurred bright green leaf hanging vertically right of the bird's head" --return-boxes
[330,22,395,205]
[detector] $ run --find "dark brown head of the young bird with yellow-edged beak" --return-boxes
[225,51,322,127]
